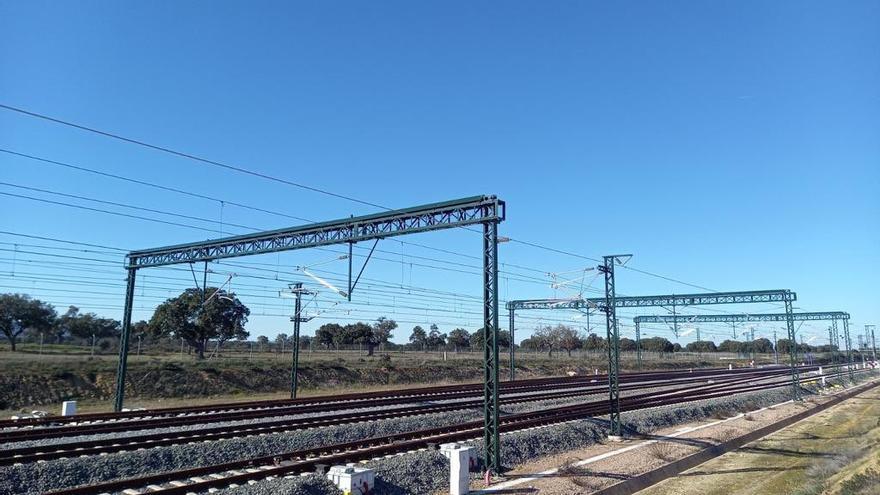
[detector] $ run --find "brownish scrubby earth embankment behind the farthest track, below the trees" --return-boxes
[0,359,624,410]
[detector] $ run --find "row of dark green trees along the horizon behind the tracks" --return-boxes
[0,287,837,359]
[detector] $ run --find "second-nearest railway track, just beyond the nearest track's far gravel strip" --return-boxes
[0,370,804,466]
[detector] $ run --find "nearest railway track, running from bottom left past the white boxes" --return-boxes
[43,371,868,495]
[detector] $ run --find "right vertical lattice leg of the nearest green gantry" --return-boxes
[483,222,501,473]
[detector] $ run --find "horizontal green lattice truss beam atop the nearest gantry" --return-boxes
[128,196,505,268]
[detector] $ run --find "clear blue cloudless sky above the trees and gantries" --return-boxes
[0,0,880,341]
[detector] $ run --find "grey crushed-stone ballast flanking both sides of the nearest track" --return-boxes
[0,374,868,495]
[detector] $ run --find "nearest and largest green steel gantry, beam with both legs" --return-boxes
[114,196,505,472]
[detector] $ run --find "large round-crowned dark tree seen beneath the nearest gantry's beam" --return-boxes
[150,287,251,359]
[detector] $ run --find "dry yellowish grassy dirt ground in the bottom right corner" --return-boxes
[638,388,880,495]
